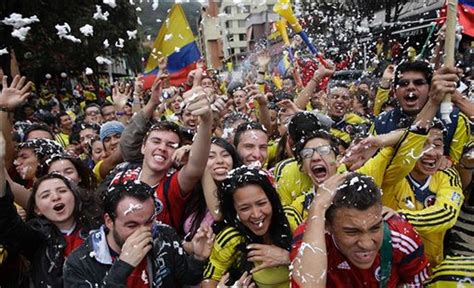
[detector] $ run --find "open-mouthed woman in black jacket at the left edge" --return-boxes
[0,133,94,287]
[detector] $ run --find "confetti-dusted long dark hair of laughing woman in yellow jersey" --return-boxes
[219,166,292,279]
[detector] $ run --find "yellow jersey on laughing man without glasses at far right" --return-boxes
[382,169,464,266]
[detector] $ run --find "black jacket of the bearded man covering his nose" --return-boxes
[64,224,206,287]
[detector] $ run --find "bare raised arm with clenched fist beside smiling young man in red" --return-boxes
[178,86,212,197]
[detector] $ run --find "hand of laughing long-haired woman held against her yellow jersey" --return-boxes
[247,244,290,273]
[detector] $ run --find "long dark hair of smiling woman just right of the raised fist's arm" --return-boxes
[181,137,241,239]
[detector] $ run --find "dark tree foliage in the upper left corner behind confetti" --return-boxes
[0,0,140,78]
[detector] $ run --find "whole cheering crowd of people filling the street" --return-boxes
[0,20,474,287]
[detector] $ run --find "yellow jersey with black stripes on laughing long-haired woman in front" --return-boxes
[204,207,301,287]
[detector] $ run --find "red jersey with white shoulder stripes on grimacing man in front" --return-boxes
[290,216,429,288]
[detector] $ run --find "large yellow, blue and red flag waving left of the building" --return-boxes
[143,4,201,89]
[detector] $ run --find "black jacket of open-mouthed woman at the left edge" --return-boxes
[0,184,87,288]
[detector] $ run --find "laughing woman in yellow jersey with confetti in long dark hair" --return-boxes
[201,166,301,287]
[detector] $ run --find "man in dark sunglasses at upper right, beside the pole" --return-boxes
[371,61,471,162]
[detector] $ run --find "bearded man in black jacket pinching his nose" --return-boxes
[64,171,214,287]
